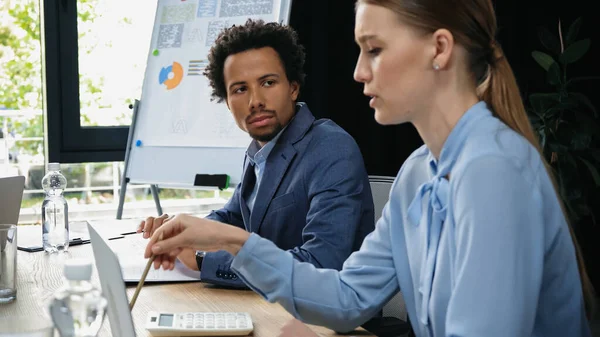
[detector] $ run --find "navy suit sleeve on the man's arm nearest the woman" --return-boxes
[290,133,375,270]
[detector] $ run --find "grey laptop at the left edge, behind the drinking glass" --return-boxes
[0,176,25,225]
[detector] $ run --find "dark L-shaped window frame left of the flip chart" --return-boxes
[40,0,129,163]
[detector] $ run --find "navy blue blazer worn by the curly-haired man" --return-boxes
[198,103,375,287]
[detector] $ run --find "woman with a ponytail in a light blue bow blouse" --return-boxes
[145,0,590,337]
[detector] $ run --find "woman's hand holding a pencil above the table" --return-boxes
[144,214,250,270]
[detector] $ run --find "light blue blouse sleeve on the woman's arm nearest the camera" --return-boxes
[446,156,544,337]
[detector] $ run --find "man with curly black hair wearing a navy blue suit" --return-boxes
[140,20,375,287]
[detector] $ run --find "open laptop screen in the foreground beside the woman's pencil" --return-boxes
[88,223,135,337]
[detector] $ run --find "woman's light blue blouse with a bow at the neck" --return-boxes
[232,102,591,337]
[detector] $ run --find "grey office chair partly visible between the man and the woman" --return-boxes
[362,176,412,337]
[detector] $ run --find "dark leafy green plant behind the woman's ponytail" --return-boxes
[526,18,600,289]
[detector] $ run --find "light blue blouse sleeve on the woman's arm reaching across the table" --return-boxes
[232,201,399,332]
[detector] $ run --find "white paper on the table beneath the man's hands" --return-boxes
[109,234,200,282]
